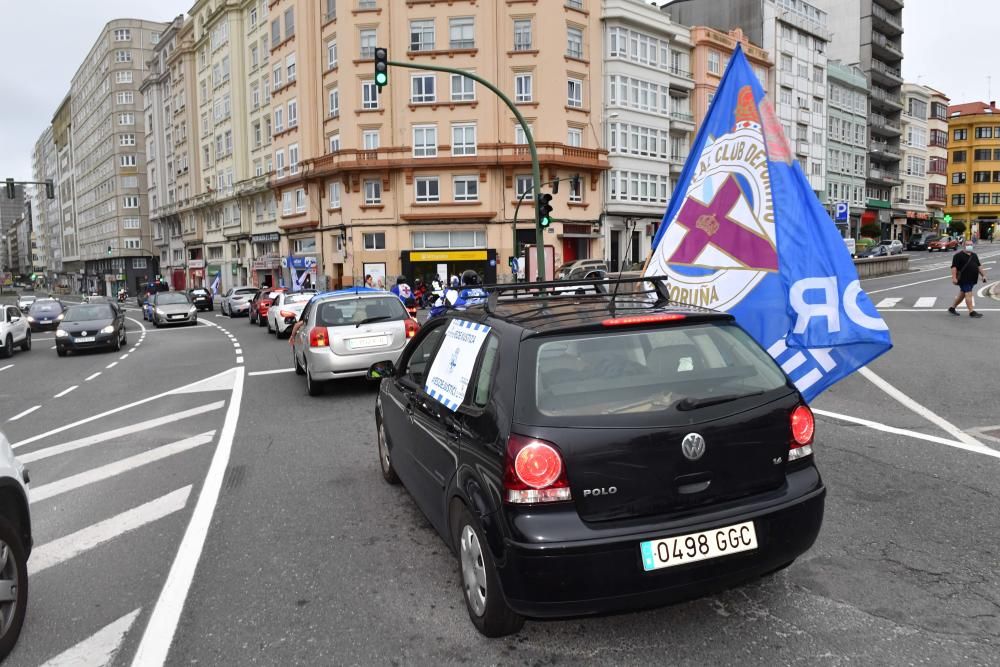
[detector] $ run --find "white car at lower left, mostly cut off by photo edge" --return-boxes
[0,432,32,661]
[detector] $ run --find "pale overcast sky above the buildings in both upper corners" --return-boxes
[0,0,1000,180]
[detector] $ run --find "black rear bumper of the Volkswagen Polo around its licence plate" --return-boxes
[499,468,826,618]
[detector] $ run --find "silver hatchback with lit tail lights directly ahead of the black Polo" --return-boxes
[292,289,420,396]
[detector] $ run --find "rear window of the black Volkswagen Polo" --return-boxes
[515,324,787,418]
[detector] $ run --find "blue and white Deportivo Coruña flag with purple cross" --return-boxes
[645,47,892,401]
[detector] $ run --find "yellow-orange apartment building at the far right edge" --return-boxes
[945,100,1000,238]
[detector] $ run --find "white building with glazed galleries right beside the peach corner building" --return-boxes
[601,0,695,270]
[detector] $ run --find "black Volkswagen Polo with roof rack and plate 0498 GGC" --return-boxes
[369,283,826,637]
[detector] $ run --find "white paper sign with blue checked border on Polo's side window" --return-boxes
[424,319,490,412]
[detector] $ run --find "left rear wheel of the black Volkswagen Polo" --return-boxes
[452,503,524,637]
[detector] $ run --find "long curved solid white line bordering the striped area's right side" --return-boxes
[132,367,244,667]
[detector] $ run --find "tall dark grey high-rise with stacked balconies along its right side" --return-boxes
[814,0,906,233]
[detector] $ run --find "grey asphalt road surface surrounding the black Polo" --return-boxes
[0,262,1000,665]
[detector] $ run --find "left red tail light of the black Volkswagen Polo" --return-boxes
[503,433,572,504]
